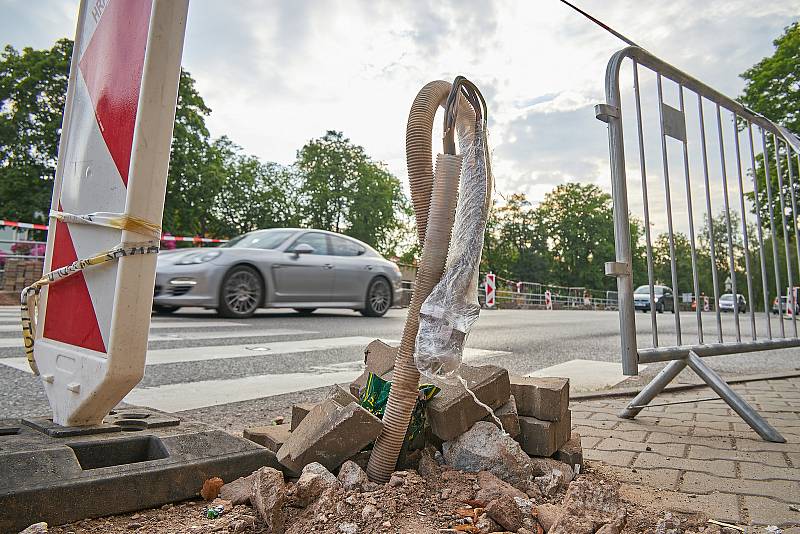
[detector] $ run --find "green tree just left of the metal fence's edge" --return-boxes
[537,183,614,294]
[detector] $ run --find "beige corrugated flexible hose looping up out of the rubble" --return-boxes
[367,81,475,483]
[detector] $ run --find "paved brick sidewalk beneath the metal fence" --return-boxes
[571,378,800,533]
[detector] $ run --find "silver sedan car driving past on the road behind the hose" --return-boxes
[153,228,401,318]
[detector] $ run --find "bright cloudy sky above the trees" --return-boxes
[0,0,800,222]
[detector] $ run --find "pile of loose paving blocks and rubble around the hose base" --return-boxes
[203,341,604,534]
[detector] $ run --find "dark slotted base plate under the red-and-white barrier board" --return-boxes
[0,408,281,532]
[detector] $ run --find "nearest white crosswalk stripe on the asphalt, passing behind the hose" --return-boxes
[125,348,508,412]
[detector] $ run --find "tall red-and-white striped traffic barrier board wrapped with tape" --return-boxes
[35,0,188,425]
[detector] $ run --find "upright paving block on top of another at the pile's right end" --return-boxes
[511,376,569,421]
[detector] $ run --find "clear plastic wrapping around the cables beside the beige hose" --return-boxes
[414,123,491,381]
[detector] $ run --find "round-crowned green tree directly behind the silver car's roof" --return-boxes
[295,131,409,253]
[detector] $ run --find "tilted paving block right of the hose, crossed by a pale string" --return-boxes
[427,365,511,441]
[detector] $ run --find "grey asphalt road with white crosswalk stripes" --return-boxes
[0,308,800,432]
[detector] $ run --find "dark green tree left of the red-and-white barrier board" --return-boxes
[0,39,72,222]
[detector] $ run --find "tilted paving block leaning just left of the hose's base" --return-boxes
[277,399,383,473]
